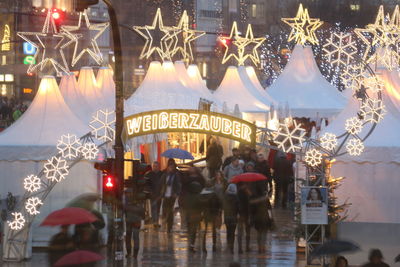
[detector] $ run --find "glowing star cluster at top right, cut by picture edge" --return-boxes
[354,6,400,70]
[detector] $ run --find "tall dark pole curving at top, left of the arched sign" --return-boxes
[103,0,124,266]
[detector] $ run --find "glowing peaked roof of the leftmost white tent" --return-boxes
[0,76,89,160]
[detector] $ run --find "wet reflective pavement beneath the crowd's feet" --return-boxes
[1,209,305,267]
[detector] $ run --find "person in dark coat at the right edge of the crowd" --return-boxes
[274,151,294,208]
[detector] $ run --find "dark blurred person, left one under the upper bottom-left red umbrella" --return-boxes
[49,225,75,266]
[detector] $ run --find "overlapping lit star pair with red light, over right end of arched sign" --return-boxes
[219,21,265,66]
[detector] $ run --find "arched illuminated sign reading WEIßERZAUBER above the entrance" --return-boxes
[124,109,256,145]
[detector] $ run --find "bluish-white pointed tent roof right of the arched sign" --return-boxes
[267,45,346,118]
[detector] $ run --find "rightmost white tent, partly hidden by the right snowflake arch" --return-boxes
[324,70,400,223]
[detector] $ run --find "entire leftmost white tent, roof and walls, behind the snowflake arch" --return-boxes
[0,76,99,246]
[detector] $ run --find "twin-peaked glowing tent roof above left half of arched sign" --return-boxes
[125,61,201,115]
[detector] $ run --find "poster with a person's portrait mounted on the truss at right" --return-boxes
[301,186,328,224]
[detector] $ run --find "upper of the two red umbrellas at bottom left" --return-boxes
[40,207,98,226]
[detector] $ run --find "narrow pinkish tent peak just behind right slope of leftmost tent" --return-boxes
[60,73,92,123]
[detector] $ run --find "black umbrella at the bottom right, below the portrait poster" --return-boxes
[311,240,360,257]
